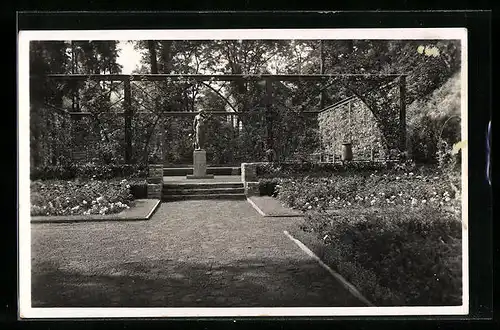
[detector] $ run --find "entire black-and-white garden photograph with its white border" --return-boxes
[19,29,468,317]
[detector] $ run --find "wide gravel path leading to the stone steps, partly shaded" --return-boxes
[31,200,368,307]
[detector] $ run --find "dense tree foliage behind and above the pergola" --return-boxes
[30,40,460,166]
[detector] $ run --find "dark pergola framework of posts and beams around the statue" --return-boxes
[38,74,406,163]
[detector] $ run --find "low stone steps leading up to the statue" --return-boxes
[162,182,246,201]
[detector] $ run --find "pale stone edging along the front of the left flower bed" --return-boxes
[31,200,161,223]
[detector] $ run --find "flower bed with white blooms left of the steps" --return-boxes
[30,179,145,216]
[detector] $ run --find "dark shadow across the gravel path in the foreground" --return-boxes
[32,259,363,307]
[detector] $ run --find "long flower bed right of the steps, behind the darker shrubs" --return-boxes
[270,171,460,211]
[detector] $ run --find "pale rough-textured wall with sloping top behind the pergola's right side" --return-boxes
[318,99,385,160]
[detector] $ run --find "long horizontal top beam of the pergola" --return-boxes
[40,73,406,81]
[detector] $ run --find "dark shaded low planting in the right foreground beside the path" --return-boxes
[302,206,462,306]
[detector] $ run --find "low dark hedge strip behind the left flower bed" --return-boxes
[30,163,147,180]
